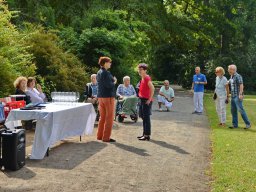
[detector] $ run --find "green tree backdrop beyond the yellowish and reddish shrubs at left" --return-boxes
[3,0,256,95]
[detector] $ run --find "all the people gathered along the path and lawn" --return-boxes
[14,57,251,142]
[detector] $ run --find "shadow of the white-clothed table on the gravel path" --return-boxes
[27,141,107,170]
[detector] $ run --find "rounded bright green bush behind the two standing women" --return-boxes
[74,10,148,84]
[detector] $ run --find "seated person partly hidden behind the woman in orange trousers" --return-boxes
[84,74,99,121]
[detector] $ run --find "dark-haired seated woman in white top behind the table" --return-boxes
[26,77,46,103]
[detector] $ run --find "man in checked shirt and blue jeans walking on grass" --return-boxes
[228,65,251,129]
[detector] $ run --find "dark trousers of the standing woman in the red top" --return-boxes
[139,99,152,135]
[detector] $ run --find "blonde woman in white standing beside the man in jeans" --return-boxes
[215,67,229,126]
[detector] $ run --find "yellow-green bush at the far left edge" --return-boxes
[0,1,35,97]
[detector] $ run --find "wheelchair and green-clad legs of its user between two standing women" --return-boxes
[115,97,139,123]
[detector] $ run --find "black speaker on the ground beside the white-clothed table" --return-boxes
[1,129,26,171]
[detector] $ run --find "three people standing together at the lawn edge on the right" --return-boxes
[191,64,251,129]
